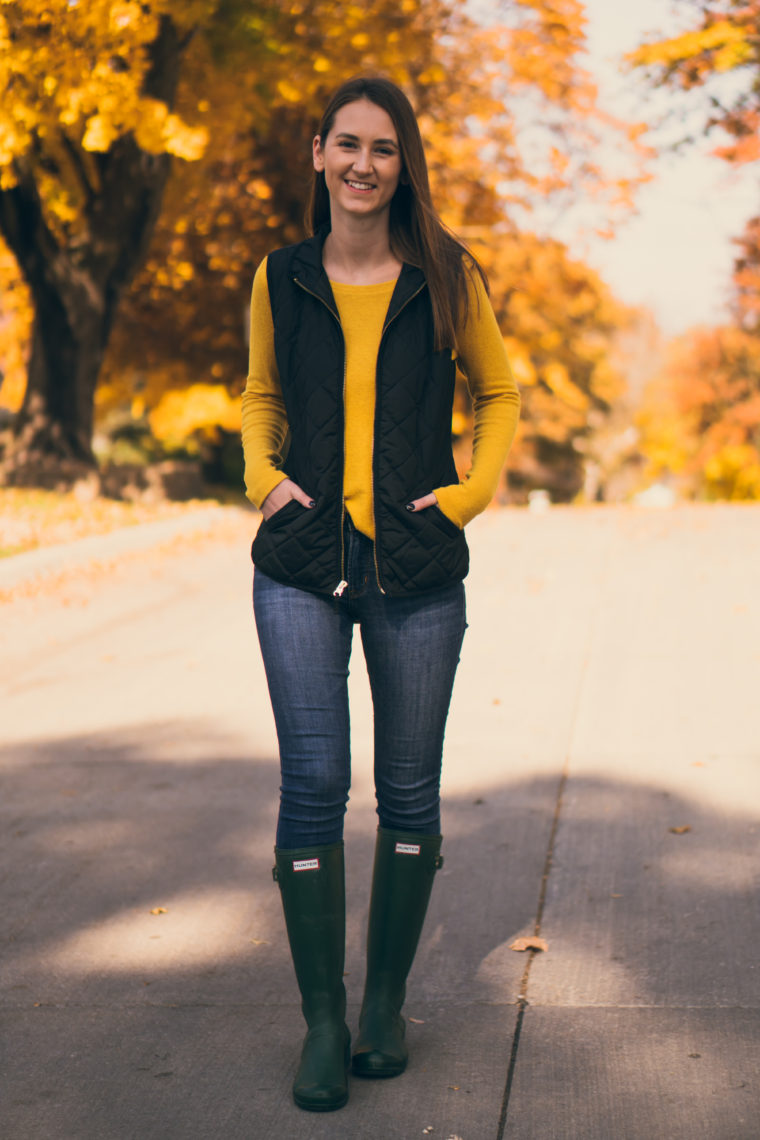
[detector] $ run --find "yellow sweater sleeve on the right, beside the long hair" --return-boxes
[434,272,520,527]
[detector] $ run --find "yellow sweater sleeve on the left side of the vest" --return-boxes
[243,258,288,507]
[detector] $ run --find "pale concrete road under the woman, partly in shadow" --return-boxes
[0,506,760,1140]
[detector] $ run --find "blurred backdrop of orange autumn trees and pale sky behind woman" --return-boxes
[0,0,760,542]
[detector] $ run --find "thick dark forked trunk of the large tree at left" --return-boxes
[0,18,182,482]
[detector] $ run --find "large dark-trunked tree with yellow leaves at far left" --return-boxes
[0,0,209,462]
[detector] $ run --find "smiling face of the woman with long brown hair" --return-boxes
[313,99,401,217]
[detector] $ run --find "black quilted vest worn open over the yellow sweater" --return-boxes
[251,230,469,596]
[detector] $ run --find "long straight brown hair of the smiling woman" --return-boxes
[307,75,488,349]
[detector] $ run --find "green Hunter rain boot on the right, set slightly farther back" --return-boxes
[353,828,443,1077]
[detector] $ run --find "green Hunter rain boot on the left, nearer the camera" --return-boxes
[272,842,351,1113]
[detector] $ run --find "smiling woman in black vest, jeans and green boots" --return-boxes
[243,78,520,1112]
